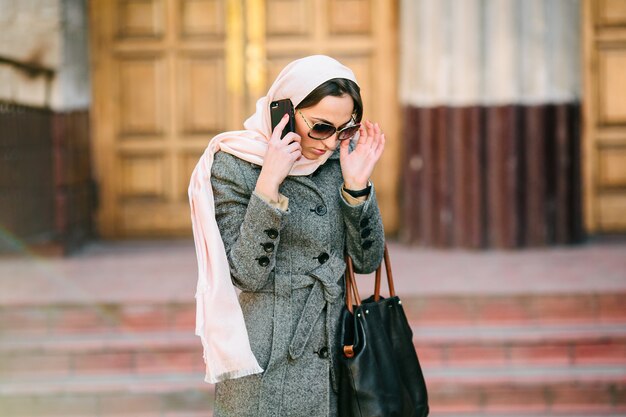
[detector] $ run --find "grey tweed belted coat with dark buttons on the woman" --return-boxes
[211,148,384,417]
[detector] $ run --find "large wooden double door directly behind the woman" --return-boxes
[91,0,400,237]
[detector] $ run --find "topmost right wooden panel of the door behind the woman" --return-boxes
[328,0,372,35]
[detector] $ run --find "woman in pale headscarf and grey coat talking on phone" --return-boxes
[189,55,385,417]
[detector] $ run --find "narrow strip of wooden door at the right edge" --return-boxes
[583,0,626,233]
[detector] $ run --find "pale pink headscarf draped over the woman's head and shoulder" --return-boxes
[188,55,356,383]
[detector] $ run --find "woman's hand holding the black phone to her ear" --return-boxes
[256,114,302,201]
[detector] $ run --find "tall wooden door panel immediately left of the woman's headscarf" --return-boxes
[178,55,228,135]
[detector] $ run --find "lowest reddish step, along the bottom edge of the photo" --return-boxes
[0,368,626,417]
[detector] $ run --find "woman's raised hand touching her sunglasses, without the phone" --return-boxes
[340,120,385,190]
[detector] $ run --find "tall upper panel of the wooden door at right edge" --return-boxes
[597,49,626,124]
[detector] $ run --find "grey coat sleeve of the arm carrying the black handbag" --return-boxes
[339,185,385,274]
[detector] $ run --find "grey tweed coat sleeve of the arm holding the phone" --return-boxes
[211,152,289,291]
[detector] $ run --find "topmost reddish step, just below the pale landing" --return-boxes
[0,293,626,335]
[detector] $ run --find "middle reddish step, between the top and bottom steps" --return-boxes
[0,323,626,376]
